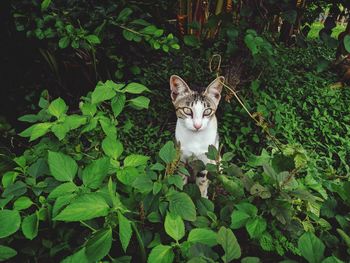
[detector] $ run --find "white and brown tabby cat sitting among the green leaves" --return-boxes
[170,75,225,198]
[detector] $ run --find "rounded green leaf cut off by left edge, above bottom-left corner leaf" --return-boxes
[0,209,21,238]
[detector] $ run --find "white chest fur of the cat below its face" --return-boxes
[175,116,219,163]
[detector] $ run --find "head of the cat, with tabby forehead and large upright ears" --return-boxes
[170,75,225,131]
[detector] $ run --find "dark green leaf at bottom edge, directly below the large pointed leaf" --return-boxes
[85,227,112,262]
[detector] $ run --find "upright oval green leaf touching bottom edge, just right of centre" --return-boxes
[217,226,241,263]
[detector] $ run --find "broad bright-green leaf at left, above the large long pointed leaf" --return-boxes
[48,151,78,182]
